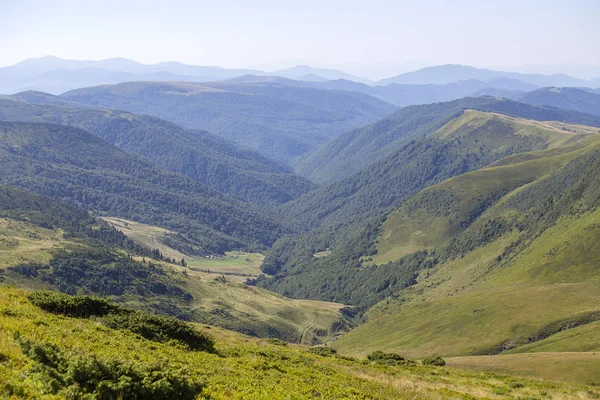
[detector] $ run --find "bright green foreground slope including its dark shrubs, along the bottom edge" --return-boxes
[0,286,599,400]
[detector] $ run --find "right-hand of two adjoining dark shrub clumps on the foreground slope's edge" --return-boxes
[101,311,214,351]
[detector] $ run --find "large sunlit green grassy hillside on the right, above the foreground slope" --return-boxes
[335,116,600,372]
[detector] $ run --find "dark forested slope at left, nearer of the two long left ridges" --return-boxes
[0,122,285,252]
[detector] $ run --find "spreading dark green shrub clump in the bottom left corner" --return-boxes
[15,335,203,400]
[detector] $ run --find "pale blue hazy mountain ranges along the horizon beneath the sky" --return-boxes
[0,56,600,97]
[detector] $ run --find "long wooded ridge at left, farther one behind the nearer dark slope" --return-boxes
[0,97,314,205]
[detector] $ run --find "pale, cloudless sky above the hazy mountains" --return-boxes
[0,0,600,77]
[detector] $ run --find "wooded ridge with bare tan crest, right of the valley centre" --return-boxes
[282,110,596,230]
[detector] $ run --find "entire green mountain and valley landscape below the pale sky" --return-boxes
[0,28,600,400]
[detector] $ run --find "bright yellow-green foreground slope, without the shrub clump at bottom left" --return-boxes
[0,286,599,400]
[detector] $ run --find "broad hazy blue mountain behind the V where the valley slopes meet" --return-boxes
[61,82,396,162]
